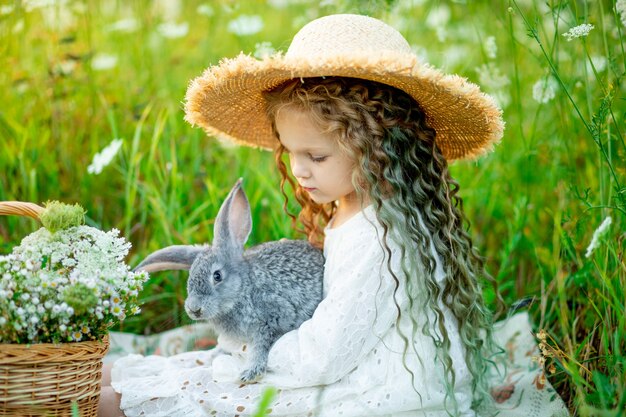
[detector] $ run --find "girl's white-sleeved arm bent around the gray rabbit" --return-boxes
[264,227,406,387]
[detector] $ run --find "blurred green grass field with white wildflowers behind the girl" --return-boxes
[0,0,626,416]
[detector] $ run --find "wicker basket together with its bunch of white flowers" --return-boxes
[0,202,148,417]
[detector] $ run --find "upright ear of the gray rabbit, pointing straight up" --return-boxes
[213,178,252,253]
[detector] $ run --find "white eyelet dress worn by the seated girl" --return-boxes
[112,206,475,417]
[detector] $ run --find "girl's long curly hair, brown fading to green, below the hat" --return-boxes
[264,77,502,412]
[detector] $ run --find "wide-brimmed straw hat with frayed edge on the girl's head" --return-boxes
[185,14,504,160]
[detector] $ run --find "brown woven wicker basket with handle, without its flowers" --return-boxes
[0,201,109,417]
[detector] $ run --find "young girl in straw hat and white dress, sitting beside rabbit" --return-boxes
[100,15,564,416]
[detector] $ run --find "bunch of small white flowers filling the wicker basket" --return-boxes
[0,226,148,343]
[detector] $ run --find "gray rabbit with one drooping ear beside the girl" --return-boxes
[135,179,324,383]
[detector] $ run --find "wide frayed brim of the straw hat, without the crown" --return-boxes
[185,52,504,160]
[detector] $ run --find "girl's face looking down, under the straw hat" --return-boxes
[276,107,356,212]
